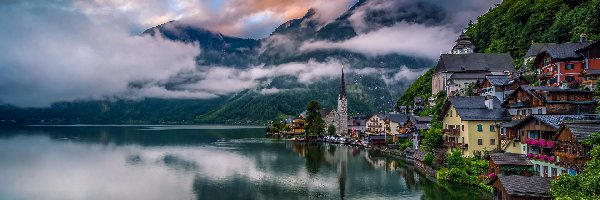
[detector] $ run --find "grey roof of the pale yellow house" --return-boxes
[448,96,511,121]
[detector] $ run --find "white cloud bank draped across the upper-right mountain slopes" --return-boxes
[300,0,501,60]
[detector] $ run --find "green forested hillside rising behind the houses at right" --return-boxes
[396,0,600,109]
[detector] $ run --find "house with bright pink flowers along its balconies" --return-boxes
[506,115,598,177]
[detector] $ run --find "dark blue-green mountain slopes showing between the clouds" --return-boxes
[0,0,446,124]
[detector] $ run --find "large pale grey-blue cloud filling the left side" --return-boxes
[0,2,204,107]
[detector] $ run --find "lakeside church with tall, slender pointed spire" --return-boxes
[324,66,348,135]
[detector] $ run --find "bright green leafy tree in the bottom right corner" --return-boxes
[550,132,600,200]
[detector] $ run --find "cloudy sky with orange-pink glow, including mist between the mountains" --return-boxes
[0,0,498,107]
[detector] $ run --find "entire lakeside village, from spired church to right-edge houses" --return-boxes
[271,34,600,199]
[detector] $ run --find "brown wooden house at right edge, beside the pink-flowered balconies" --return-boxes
[554,120,600,175]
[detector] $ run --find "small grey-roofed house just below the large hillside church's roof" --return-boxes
[476,75,529,101]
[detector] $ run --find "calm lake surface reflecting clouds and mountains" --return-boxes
[0,126,491,200]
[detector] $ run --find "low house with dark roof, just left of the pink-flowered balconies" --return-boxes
[487,153,533,176]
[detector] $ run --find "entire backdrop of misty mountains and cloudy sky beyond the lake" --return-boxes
[0,0,498,122]
